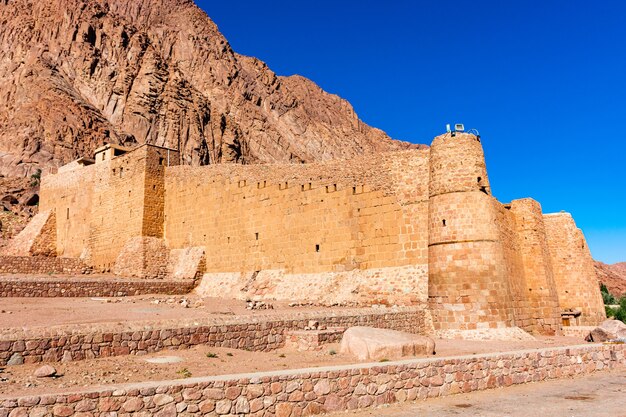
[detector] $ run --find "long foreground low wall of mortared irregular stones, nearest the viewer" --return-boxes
[0,344,626,417]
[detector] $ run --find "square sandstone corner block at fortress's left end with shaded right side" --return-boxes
[41,145,178,270]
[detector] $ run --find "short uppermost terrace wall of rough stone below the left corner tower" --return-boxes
[0,256,91,275]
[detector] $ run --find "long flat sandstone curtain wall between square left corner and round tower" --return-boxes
[165,150,428,300]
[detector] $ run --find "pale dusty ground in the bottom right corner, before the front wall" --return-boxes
[326,370,626,417]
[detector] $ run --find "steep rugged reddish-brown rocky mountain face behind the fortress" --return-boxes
[0,0,416,176]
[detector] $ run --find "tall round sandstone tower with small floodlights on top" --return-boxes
[428,132,513,336]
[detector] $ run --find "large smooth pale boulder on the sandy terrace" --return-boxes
[340,327,435,361]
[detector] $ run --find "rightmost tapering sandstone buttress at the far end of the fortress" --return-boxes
[543,213,606,326]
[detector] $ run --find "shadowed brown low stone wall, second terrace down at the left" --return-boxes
[0,274,195,297]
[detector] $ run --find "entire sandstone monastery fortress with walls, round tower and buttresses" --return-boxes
[9,133,604,337]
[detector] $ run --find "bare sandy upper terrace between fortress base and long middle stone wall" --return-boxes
[0,295,338,328]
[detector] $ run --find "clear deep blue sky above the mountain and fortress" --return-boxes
[198,0,626,263]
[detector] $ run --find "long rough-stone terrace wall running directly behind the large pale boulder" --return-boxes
[0,308,426,365]
